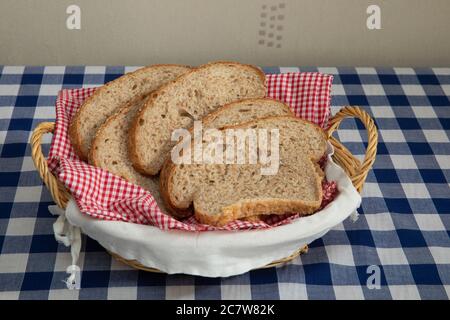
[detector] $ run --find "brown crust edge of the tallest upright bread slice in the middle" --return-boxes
[128,61,267,175]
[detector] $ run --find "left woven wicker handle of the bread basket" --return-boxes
[30,122,69,209]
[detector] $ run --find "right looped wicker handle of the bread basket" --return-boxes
[326,106,378,192]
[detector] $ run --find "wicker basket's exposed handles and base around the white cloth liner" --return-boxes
[31,107,378,272]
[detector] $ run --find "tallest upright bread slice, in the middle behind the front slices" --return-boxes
[128,62,266,175]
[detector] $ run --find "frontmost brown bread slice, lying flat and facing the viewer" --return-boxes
[160,116,326,226]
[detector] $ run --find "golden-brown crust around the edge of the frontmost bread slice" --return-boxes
[160,116,327,226]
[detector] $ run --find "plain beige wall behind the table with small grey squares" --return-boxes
[0,0,450,66]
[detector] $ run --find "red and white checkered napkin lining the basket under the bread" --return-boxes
[48,73,337,231]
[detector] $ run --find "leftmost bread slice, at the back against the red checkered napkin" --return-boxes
[69,65,189,160]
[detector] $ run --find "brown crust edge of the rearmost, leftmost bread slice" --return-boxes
[68,64,191,161]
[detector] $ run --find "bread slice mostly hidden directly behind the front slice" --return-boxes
[161,98,294,221]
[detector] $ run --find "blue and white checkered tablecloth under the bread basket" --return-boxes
[0,66,450,299]
